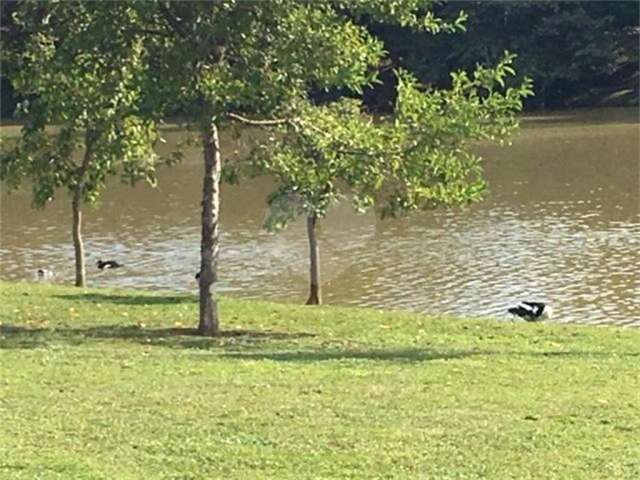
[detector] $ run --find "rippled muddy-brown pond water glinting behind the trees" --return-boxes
[0,110,640,325]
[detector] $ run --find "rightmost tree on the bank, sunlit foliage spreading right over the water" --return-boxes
[238,54,533,304]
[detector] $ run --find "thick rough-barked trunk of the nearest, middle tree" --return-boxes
[198,122,221,336]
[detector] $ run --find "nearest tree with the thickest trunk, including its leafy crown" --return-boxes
[129,0,390,335]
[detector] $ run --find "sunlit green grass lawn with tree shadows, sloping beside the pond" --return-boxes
[0,283,640,480]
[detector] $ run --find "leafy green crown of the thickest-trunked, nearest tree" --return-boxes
[126,0,460,123]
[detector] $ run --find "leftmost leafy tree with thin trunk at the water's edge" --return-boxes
[0,3,157,286]
